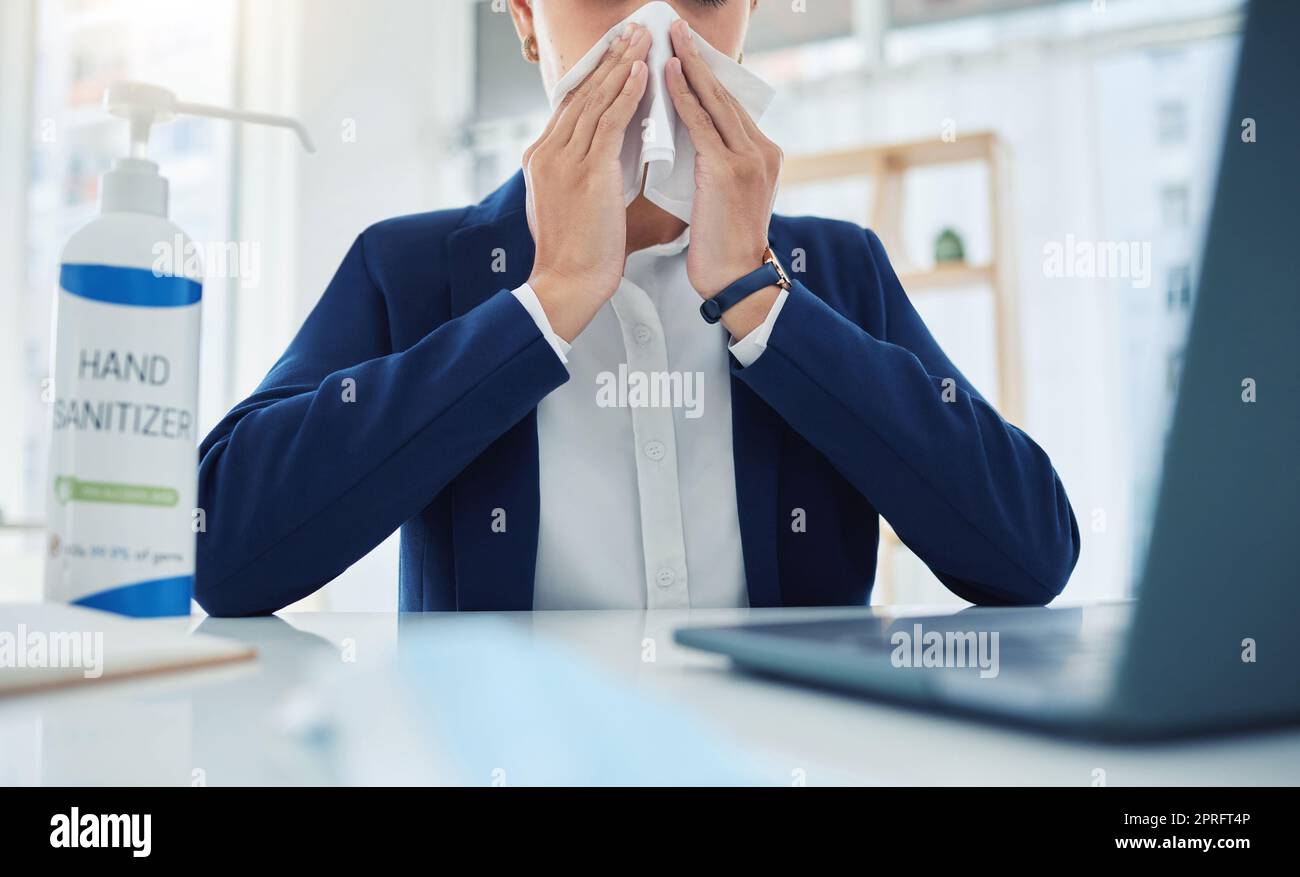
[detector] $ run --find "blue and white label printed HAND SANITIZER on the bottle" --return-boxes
[46,264,203,616]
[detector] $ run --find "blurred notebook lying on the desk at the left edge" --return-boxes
[0,603,256,698]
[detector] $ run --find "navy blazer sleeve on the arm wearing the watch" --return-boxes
[733,230,1079,605]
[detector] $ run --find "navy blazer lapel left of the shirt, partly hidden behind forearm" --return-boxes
[447,174,540,609]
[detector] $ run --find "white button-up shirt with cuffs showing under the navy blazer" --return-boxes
[514,229,787,609]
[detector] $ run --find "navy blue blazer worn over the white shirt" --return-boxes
[195,167,1079,616]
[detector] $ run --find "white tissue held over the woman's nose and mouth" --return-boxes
[550,0,774,222]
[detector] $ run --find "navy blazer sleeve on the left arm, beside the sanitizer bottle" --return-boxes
[194,235,568,616]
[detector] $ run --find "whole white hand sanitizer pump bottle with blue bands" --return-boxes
[46,83,312,616]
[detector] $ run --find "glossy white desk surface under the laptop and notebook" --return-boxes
[0,609,1300,786]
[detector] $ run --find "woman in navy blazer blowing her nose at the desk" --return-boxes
[195,0,1079,615]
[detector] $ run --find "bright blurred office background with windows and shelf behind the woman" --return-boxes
[0,0,1243,609]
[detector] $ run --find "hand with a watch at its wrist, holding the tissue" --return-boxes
[664,19,783,338]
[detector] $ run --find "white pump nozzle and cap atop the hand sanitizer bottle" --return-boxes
[101,82,316,216]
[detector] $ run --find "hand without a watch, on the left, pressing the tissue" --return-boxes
[524,25,650,342]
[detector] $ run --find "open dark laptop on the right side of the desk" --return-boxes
[675,3,1300,738]
